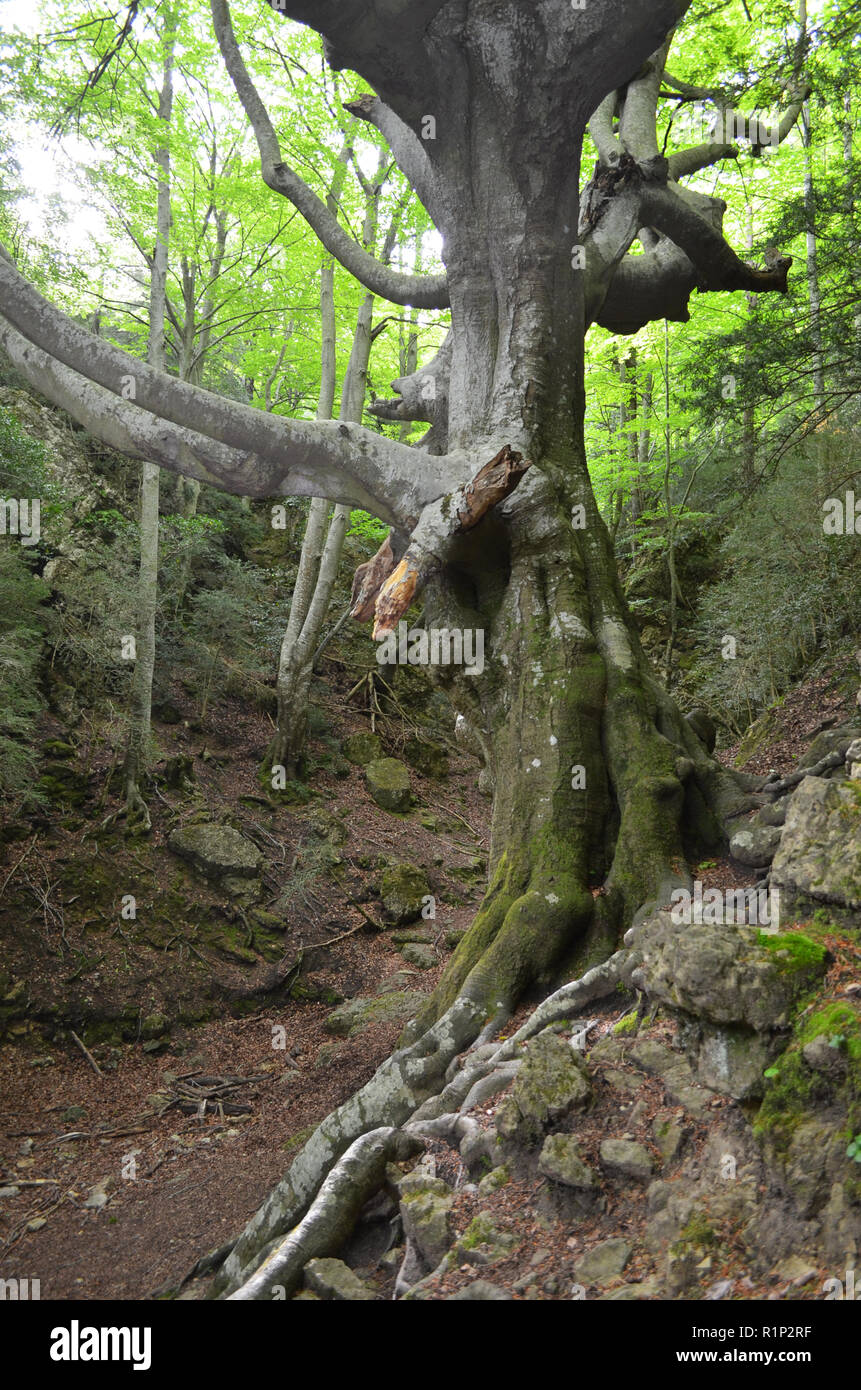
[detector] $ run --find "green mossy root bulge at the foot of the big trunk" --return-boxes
[405,852,594,1038]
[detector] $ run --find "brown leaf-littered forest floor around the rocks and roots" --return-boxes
[0,656,858,1300]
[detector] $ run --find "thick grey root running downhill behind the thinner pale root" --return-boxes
[205,999,483,1297]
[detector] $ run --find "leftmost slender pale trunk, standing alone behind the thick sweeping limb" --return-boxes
[122,8,175,831]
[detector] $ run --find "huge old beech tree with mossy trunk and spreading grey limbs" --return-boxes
[0,0,804,1298]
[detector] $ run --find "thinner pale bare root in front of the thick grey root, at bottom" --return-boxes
[228,1126,421,1302]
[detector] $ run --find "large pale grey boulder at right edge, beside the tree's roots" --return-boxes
[771,777,861,909]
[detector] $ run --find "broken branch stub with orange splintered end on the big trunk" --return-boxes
[366,443,531,639]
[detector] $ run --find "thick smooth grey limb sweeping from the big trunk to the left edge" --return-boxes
[0,254,463,530]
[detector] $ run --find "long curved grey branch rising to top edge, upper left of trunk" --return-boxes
[211,0,449,309]
